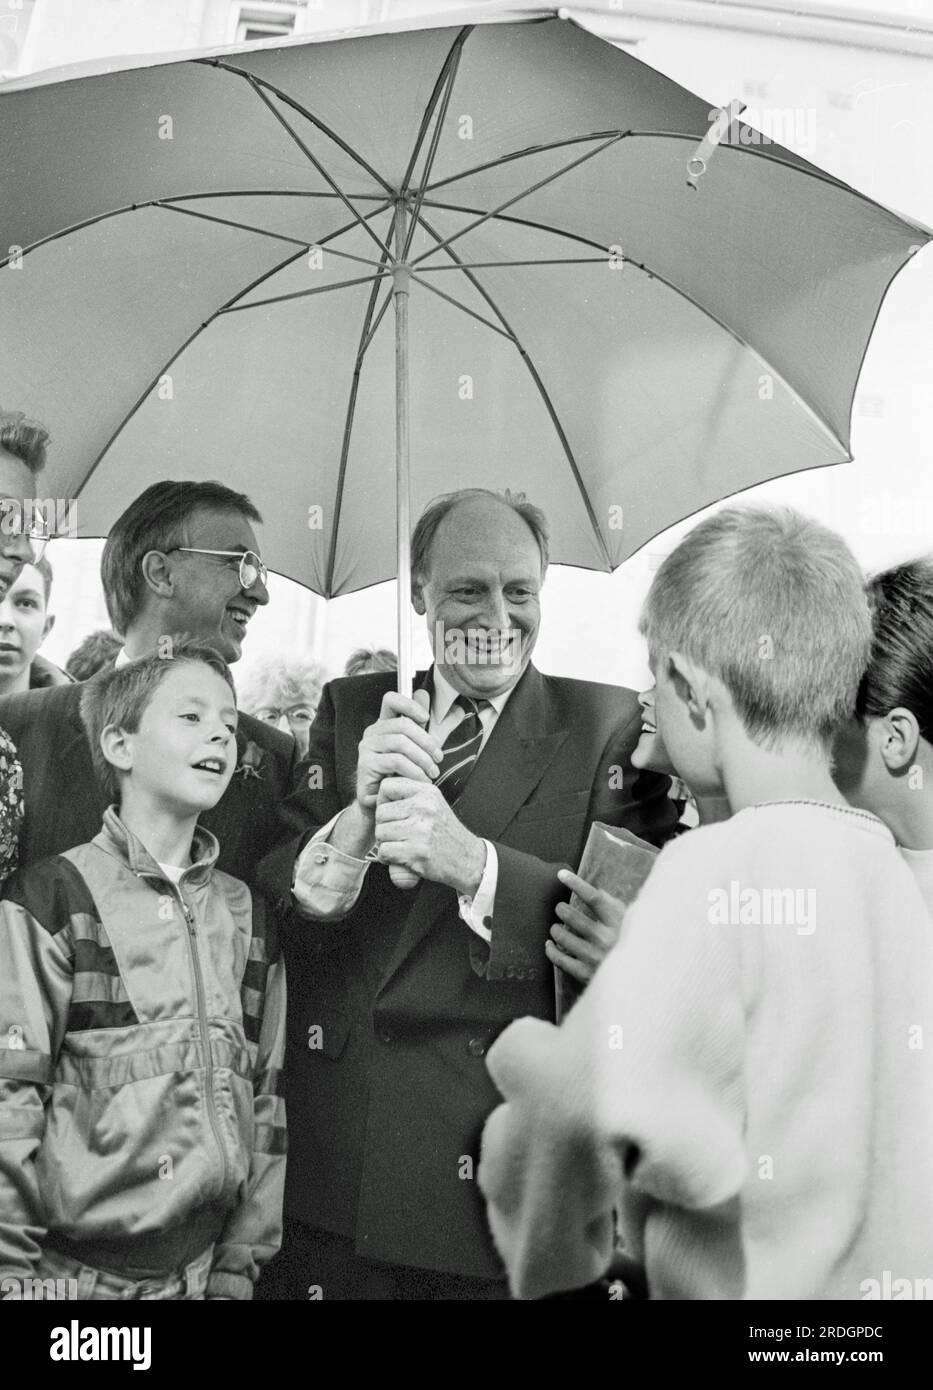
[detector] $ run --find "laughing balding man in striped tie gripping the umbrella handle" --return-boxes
[260,489,676,1298]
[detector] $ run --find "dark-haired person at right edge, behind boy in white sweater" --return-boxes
[836,560,933,910]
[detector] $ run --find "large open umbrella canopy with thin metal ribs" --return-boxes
[0,9,930,596]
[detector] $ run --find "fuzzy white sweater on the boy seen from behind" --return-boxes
[478,802,933,1298]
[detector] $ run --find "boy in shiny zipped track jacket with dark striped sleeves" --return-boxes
[0,639,285,1300]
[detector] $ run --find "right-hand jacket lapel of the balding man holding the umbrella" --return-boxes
[382,666,570,988]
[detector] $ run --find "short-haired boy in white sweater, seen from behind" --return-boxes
[478,507,933,1298]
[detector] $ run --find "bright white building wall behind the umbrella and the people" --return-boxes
[14,0,933,685]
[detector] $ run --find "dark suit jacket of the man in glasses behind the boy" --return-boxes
[0,684,298,883]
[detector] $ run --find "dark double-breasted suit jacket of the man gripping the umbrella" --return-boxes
[260,667,677,1277]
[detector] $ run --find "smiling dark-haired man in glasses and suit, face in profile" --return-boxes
[0,483,298,883]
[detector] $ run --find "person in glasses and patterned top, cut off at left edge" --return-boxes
[0,410,49,883]
